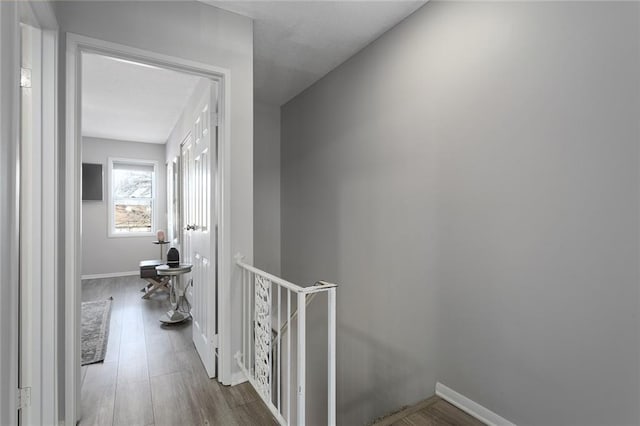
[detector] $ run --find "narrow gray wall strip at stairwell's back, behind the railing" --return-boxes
[253,102,281,276]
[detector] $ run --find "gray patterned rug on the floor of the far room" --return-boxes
[80,297,113,365]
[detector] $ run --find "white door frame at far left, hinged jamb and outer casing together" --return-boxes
[19,2,58,424]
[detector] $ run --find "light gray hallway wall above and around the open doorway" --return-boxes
[54,1,253,420]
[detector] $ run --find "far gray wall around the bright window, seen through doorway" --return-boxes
[82,137,167,275]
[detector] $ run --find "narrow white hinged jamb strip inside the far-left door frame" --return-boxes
[19,21,44,425]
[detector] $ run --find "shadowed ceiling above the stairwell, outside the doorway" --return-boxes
[202,0,426,105]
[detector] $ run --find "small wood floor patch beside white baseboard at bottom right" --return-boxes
[373,396,484,426]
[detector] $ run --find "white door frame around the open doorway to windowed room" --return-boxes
[64,33,233,426]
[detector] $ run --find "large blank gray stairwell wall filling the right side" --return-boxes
[281,2,640,425]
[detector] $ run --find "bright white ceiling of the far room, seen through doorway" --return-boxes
[82,54,200,143]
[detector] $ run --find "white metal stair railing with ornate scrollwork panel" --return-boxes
[235,257,337,426]
